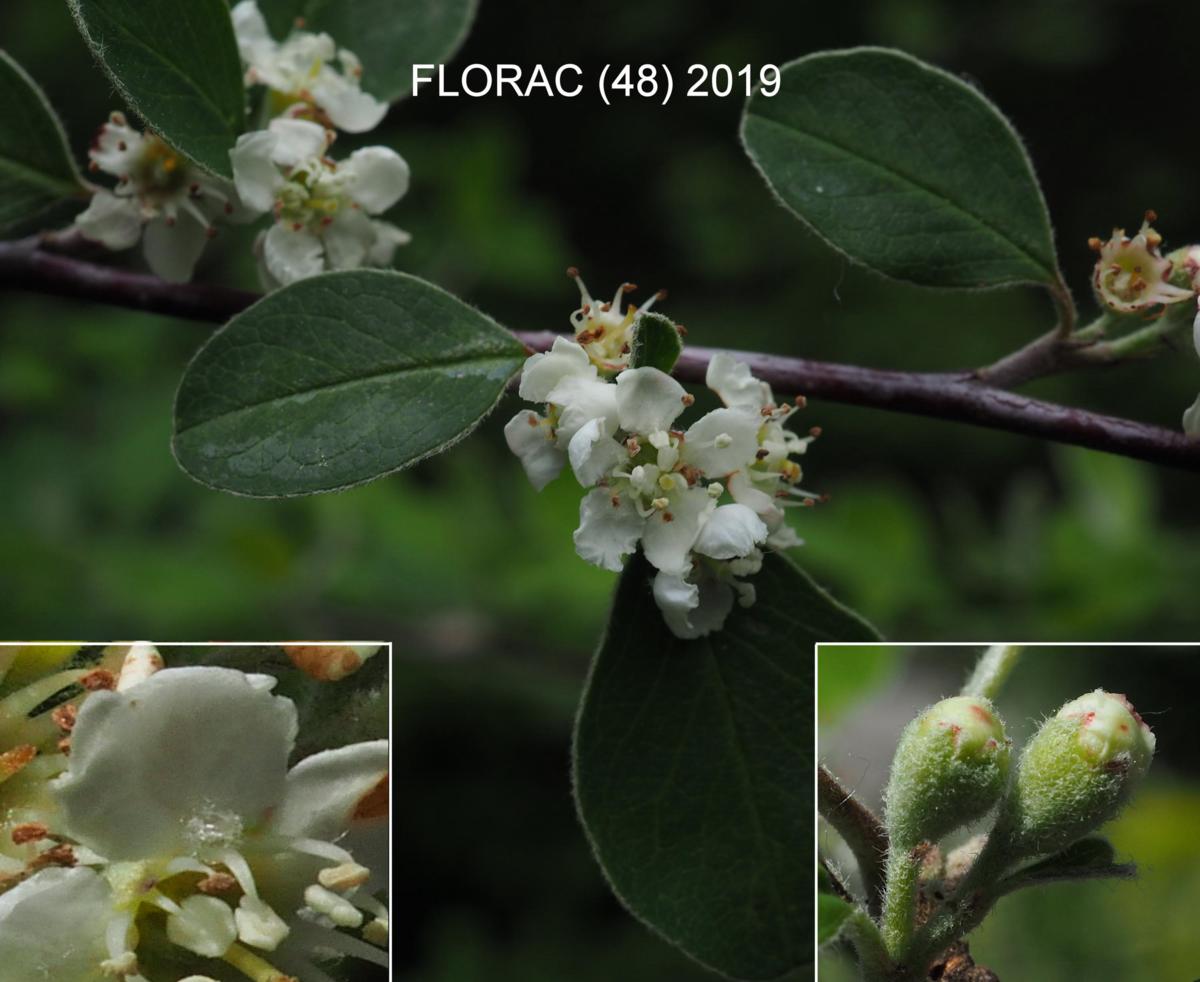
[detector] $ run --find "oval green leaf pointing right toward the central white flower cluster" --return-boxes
[174,270,527,497]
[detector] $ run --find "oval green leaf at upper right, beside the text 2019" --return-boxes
[742,48,1058,287]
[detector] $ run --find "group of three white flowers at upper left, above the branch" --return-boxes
[76,0,409,289]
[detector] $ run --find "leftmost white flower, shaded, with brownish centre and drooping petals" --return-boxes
[76,113,241,282]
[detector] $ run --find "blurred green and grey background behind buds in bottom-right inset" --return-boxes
[817,645,1200,982]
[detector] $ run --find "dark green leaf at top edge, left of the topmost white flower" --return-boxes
[70,0,246,178]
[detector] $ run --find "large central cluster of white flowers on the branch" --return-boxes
[504,270,815,637]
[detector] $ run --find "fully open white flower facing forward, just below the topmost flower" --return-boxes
[229,116,409,287]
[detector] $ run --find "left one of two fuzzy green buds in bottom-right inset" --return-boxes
[887,695,1012,849]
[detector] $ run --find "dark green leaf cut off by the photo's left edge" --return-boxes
[0,49,84,232]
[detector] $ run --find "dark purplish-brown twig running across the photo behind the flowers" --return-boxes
[7,239,1200,472]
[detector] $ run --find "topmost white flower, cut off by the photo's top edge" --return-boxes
[232,0,388,133]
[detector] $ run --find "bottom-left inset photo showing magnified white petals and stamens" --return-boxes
[0,641,391,982]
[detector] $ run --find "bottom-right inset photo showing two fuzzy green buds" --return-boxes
[816,643,1200,982]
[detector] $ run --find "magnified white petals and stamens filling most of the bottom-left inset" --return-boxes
[0,645,389,982]
